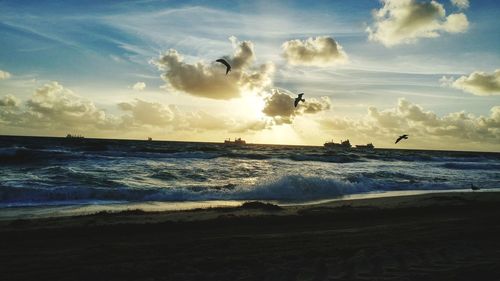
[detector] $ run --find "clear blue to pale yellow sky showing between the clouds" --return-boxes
[0,0,500,149]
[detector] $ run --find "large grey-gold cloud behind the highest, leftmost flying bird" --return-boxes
[153,37,274,100]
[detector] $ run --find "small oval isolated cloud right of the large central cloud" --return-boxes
[282,36,347,66]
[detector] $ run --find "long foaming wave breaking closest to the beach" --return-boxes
[0,175,456,206]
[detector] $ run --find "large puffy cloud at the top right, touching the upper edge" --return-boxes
[366,0,469,47]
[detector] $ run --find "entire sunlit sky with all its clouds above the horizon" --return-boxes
[0,0,500,151]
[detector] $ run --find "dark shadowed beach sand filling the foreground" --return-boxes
[0,192,500,281]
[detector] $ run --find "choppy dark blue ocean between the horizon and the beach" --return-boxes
[0,136,500,217]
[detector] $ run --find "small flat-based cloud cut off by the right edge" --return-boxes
[448,69,500,96]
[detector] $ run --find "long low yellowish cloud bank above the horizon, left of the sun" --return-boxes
[0,81,272,134]
